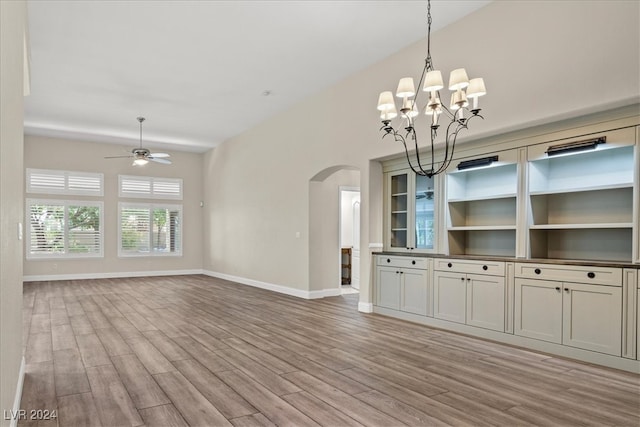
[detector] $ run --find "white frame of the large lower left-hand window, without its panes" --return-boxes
[25,198,104,261]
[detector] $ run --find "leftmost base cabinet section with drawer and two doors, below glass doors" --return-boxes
[375,256,431,316]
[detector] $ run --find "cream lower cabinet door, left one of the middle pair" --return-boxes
[433,271,467,323]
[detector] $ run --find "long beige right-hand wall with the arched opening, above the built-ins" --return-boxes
[204,1,640,303]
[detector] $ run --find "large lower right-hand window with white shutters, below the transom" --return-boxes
[118,203,182,256]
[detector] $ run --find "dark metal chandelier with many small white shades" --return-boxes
[378,0,487,177]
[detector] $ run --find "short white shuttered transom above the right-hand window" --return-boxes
[118,175,182,200]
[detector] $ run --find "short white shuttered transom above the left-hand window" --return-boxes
[27,169,104,196]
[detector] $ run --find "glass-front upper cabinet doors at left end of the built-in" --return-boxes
[386,171,435,251]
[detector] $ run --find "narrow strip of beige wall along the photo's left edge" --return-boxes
[0,1,26,426]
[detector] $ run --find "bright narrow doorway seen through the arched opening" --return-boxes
[339,186,360,293]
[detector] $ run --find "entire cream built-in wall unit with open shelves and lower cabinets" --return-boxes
[374,111,640,371]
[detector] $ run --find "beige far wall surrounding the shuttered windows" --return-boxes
[23,136,203,280]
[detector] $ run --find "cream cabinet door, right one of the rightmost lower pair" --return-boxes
[562,283,622,356]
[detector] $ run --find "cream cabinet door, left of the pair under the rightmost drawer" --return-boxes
[514,279,562,344]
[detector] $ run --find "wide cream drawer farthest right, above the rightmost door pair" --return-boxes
[515,263,622,286]
